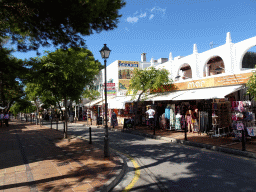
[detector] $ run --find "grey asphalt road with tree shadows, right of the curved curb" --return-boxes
[106,130,256,191]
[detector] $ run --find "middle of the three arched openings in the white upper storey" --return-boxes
[204,56,225,77]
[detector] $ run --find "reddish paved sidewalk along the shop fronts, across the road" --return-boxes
[81,121,256,154]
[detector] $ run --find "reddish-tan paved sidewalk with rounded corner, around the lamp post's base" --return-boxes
[0,120,124,192]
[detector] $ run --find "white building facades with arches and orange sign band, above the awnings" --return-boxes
[89,32,256,106]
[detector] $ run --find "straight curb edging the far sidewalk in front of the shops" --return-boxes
[123,130,256,159]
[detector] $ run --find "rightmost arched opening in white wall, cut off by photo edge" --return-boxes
[242,46,256,70]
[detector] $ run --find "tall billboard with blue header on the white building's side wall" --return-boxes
[118,61,139,90]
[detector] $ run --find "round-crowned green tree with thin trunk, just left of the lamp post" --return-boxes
[29,48,103,137]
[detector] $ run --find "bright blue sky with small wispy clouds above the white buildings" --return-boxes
[13,0,256,65]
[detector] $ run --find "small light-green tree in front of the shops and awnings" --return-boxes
[128,67,170,127]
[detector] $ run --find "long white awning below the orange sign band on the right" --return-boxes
[172,85,244,101]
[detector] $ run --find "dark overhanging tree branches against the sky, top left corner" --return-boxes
[0,0,125,51]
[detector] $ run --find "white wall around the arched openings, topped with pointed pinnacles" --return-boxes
[156,33,256,81]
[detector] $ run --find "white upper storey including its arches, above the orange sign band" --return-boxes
[156,32,256,81]
